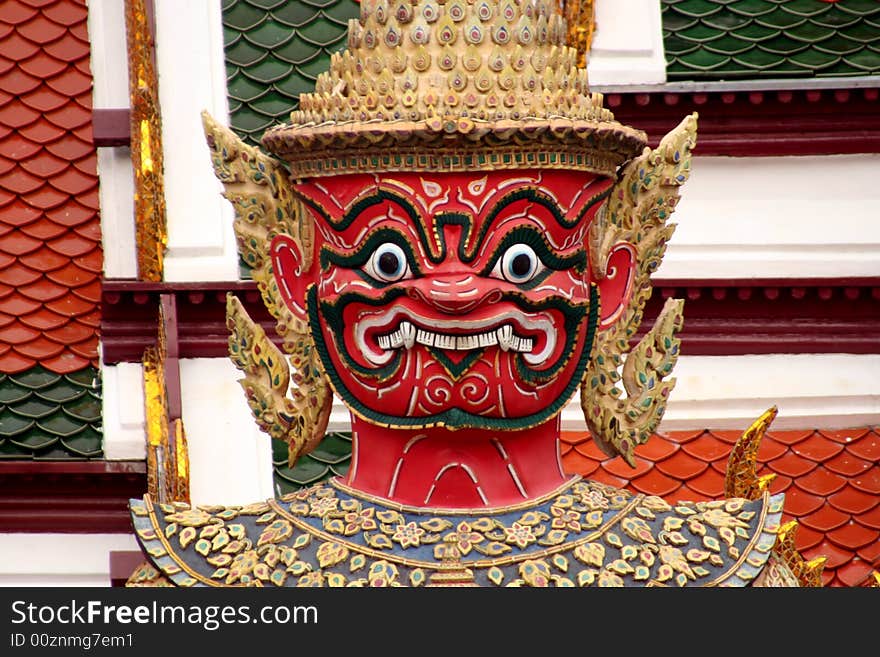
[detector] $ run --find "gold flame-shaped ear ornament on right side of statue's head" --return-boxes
[581,113,697,467]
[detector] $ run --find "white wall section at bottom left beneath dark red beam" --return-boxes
[0,534,140,587]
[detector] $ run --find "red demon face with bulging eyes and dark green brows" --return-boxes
[271,171,626,429]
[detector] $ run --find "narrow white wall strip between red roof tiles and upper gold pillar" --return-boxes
[88,0,137,278]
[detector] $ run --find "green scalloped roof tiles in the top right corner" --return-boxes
[661,0,880,81]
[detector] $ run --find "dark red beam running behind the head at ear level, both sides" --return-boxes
[101,278,880,364]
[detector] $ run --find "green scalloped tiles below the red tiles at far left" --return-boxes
[0,366,103,460]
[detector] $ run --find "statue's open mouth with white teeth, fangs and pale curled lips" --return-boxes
[355,308,556,365]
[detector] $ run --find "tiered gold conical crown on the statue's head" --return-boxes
[263,0,646,177]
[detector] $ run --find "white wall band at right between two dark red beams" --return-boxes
[656,155,880,279]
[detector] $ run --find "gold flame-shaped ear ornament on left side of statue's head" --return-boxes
[202,112,333,467]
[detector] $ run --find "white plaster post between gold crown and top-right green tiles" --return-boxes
[587,0,666,88]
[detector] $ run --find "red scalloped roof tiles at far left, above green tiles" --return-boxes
[0,0,103,374]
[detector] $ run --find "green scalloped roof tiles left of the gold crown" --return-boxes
[223,0,360,145]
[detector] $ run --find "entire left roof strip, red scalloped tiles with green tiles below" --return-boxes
[0,0,103,459]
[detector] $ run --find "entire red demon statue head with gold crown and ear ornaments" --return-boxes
[209,0,695,482]
